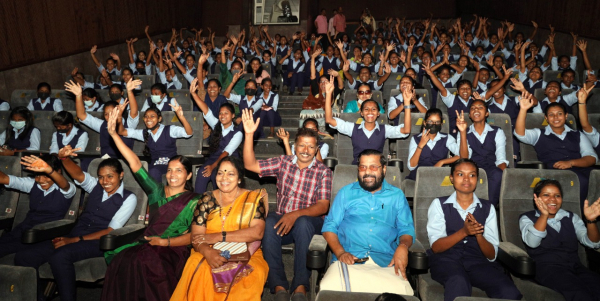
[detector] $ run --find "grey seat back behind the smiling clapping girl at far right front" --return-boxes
[499,168,584,265]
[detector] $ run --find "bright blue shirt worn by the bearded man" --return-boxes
[322,180,415,267]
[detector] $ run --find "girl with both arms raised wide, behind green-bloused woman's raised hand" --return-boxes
[65,79,142,158]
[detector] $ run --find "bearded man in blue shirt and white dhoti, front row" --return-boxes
[321,149,415,295]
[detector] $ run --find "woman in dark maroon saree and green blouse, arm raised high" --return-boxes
[102,108,200,301]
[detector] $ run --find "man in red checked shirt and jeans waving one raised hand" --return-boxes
[242,110,332,301]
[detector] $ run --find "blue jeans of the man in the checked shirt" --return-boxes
[262,214,323,292]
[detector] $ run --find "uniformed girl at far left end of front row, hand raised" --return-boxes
[0,155,76,258]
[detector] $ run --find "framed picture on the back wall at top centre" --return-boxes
[254,0,301,25]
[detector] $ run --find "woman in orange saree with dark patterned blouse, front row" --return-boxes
[171,157,269,301]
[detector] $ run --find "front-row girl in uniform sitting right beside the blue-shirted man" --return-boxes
[427,159,523,301]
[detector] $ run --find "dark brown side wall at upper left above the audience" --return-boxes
[0,0,201,100]
